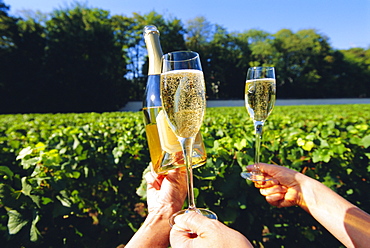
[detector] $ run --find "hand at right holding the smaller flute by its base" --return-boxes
[247,163,306,207]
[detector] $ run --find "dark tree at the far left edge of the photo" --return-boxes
[0,2,45,113]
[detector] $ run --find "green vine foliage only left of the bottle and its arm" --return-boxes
[0,113,148,247]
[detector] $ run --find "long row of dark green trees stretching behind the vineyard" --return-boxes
[0,0,370,113]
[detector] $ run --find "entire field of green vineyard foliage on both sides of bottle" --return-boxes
[0,105,370,247]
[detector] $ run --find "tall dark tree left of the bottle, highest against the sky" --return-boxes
[44,4,128,112]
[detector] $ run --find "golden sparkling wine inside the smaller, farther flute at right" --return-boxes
[245,78,276,121]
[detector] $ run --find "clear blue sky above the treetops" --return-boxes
[0,0,370,49]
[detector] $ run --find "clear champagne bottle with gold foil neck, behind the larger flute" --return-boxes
[143,25,207,174]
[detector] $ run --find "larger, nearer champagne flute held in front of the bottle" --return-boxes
[160,51,217,226]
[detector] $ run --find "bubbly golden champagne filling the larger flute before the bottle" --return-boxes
[161,70,206,138]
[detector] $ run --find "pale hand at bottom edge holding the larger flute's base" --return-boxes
[170,212,253,248]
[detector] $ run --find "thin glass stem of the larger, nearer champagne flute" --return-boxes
[179,138,196,209]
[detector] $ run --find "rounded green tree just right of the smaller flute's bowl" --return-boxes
[272,29,332,98]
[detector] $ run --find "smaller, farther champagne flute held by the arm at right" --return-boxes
[241,67,276,181]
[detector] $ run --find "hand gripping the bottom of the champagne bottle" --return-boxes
[145,168,187,215]
